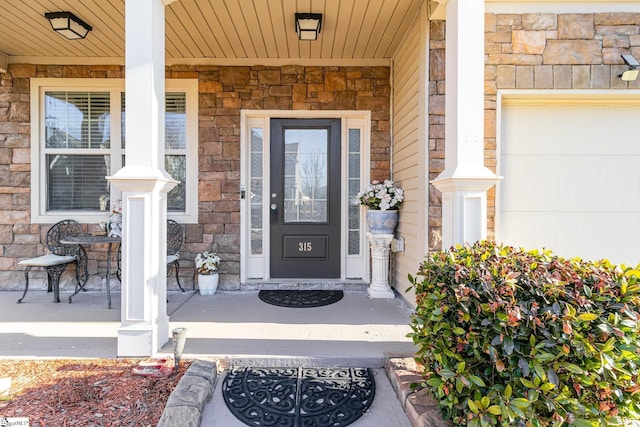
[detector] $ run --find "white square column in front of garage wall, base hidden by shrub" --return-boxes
[432,0,500,249]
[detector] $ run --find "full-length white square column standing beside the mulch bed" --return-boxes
[108,0,176,356]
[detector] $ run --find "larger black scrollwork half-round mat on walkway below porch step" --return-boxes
[222,367,375,427]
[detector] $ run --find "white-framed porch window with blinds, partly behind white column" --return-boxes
[31,79,198,223]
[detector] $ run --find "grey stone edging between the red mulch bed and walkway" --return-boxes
[158,360,218,427]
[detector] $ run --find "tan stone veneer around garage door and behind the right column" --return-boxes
[429,13,640,254]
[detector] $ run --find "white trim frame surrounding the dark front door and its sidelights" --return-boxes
[240,110,371,283]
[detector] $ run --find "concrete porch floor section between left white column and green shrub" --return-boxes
[161,291,413,368]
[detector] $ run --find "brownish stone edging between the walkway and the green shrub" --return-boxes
[385,357,452,427]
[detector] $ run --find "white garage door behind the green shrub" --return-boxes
[496,100,640,265]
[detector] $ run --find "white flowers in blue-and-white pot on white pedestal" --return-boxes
[356,179,404,234]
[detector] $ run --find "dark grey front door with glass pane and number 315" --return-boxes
[269,119,340,278]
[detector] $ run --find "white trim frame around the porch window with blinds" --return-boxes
[30,78,198,224]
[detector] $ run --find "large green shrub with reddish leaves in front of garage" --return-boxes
[409,242,640,427]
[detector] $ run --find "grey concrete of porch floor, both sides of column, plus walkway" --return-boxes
[0,291,414,427]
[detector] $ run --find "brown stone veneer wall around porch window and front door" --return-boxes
[0,64,391,289]
